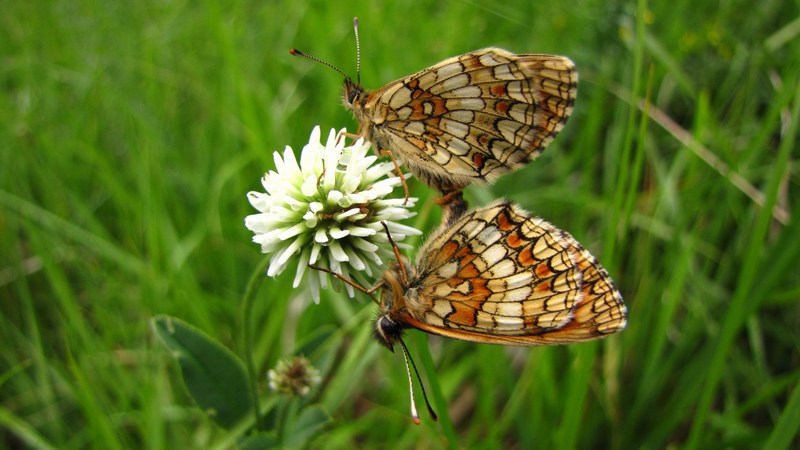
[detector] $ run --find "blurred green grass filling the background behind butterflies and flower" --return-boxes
[0,0,800,449]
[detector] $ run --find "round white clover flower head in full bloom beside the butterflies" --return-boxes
[244,126,421,303]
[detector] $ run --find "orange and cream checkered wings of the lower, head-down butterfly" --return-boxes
[403,202,626,345]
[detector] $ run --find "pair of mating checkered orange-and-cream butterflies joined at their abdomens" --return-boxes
[291,16,626,422]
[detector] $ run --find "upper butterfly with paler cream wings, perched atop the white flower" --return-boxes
[291,19,578,194]
